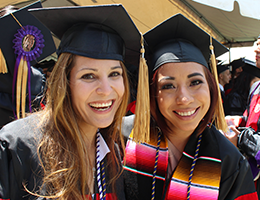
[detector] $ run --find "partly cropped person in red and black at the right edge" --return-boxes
[223,37,260,197]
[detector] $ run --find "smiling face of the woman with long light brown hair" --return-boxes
[70,56,125,130]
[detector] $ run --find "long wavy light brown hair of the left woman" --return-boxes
[38,53,129,199]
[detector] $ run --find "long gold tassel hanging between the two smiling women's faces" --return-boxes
[133,36,150,142]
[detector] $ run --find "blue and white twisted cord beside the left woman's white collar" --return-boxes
[96,130,106,200]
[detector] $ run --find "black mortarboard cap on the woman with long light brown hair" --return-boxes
[30,4,141,65]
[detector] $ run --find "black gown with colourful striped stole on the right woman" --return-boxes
[123,115,258,200]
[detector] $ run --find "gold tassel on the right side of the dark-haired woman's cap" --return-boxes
[209,37,228,132]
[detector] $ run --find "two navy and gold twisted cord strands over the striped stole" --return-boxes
[151,131,202,200]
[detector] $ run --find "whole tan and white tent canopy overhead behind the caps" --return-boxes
[0,0,260,60]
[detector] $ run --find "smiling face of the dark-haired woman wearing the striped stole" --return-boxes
[157,62,210,135]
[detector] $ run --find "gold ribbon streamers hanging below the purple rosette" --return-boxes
[16,57,28,119]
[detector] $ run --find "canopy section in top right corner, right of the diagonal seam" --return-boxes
[181,0,260,47]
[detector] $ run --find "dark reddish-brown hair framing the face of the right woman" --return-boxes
[150,64,218,137]
